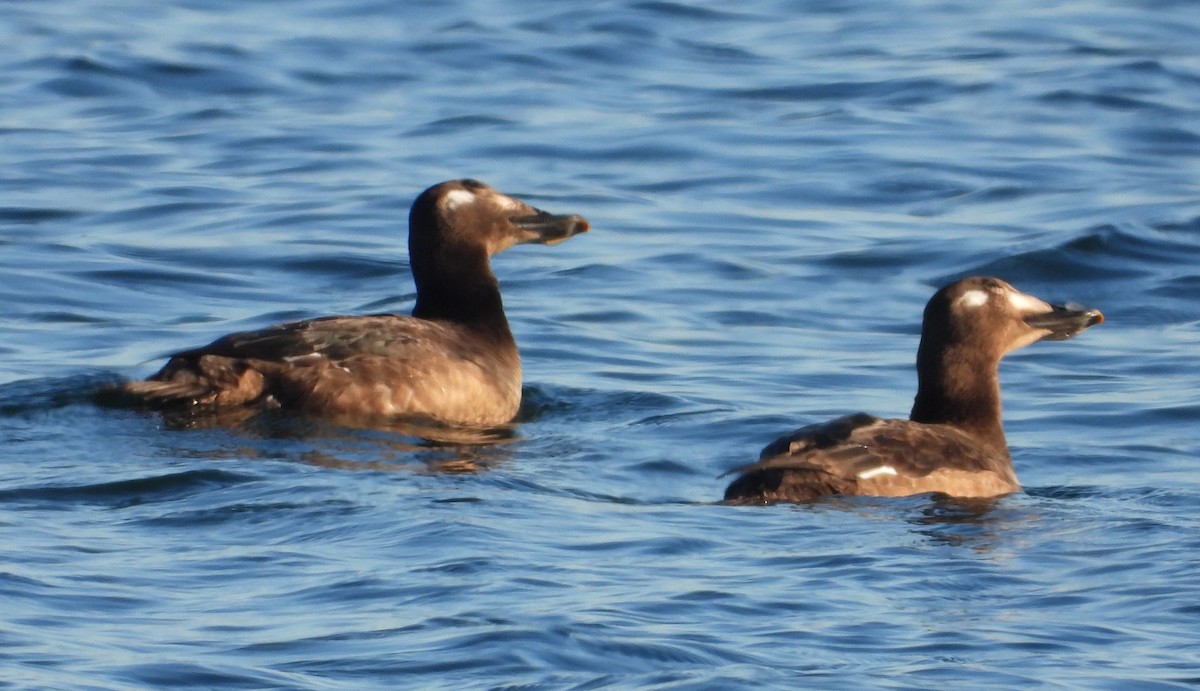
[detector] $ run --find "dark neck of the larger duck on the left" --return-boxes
[410,246,512,340]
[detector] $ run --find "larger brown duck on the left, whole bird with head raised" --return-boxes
[124,180,588,427]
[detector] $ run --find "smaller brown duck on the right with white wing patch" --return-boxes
[725,277,1104,504]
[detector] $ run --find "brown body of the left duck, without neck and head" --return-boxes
[126,314,521,426]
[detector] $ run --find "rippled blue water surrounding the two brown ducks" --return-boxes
[0,0,1200,690]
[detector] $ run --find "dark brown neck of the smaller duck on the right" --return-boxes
[910,347,1008,456]
